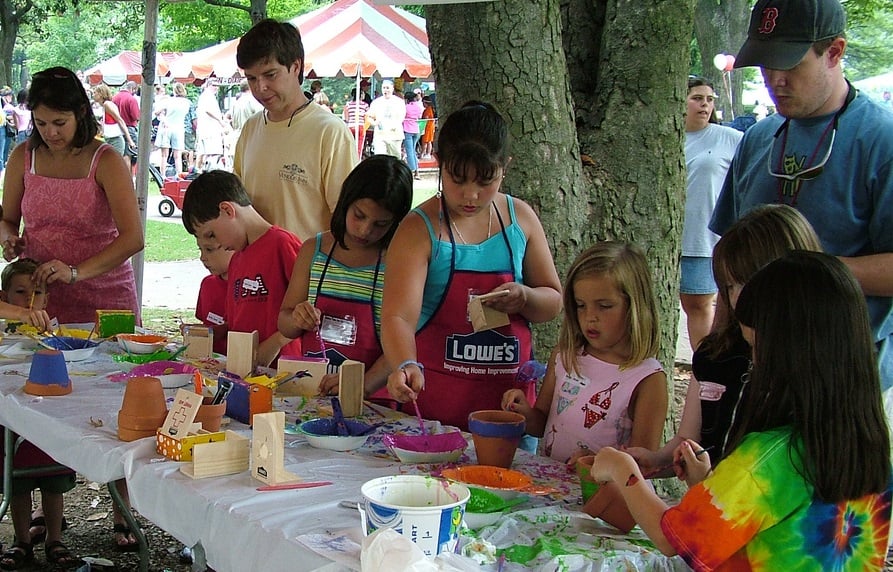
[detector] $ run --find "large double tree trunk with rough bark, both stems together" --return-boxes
[427,0,693,496]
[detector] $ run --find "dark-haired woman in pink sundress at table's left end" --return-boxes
[0,67,143,550]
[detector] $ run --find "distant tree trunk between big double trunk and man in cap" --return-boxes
[694,0,748,121]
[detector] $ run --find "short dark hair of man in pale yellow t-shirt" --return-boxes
[236,18,304,83]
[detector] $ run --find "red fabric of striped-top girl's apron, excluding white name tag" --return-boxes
[301,243,390,398]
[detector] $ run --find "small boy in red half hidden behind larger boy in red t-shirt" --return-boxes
[195,237,234,355]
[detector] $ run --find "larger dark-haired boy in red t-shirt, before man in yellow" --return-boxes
[183,170,301,366]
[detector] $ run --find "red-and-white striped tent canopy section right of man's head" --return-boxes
[291,0,431,78]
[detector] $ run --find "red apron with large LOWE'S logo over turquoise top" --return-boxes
[416,209,536,431]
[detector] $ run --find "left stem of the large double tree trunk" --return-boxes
[427,0,592,359]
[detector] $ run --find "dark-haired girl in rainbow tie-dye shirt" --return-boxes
[592,251,893,571]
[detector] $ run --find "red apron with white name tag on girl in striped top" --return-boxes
[301,245,390,398]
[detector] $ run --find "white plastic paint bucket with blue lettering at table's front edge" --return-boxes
[360,475,471,557]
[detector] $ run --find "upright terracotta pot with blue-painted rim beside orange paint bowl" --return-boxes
[468,409,526,469]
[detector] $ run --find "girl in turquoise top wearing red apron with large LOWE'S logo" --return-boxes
[382,101,561,429]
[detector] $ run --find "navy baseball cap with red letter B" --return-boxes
[735,0,846,70]
